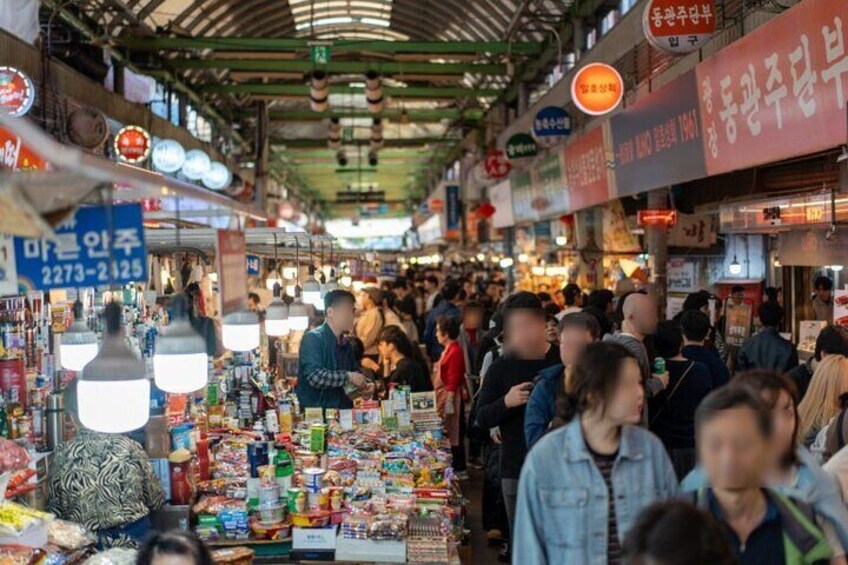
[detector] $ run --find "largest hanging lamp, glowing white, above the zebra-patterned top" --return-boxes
[78,302,150,434]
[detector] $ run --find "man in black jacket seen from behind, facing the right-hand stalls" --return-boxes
[736,302,798,373]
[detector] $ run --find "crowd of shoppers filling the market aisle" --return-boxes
[290,264,848,565]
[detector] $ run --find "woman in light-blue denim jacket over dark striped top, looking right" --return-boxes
[512,342,678,565]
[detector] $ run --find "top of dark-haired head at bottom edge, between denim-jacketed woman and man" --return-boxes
[624,501,736,565]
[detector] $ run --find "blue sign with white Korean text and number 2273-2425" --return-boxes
[15,204,147,290]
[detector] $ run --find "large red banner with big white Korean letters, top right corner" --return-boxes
[696,0,848,175]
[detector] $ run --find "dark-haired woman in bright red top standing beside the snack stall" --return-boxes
[434,316,468,478]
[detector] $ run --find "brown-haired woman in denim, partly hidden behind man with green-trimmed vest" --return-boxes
[681,370,848,556]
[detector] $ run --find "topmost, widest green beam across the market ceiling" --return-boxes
[112,37,542,55]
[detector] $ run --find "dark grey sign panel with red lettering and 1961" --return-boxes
[610,71,706,196]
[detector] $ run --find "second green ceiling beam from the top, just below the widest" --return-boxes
[167,58,507,75]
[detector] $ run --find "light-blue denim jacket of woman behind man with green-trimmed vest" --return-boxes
[681,445,848,549]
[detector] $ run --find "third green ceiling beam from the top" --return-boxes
[201,83,503,98]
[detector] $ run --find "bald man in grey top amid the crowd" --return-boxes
[604,292,668,397]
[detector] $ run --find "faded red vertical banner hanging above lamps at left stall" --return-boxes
[215,230,247,315]
